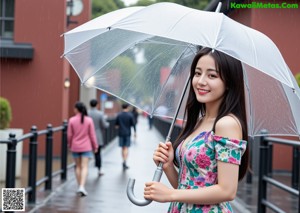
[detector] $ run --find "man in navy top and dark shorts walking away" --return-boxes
[115,103,136,170]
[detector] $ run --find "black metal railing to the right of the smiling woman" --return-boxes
[257,132,300,213]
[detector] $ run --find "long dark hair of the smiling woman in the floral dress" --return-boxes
[173,48,249,180]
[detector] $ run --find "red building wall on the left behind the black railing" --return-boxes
[0,0,91,155]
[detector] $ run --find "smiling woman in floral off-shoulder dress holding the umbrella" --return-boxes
[144,48,248,213]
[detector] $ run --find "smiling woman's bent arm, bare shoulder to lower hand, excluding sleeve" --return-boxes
[144,116,242,205]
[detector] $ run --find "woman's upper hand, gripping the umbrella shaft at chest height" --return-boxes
[153,142,174,169]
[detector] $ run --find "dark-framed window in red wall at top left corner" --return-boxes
[0,0,15,40]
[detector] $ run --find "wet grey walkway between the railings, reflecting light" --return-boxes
[27,118,253,213]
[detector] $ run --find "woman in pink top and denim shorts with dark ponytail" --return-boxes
[68,102,98,196]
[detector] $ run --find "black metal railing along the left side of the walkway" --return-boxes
[0,119,117,212]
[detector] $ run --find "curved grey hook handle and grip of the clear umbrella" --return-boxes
[127,163,163,206]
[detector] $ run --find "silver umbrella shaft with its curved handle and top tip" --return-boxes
[127,2,222,206]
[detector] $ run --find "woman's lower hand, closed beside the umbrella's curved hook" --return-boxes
[144,181,173,203]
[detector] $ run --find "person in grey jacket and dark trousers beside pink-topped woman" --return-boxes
[88,99,109,176]
